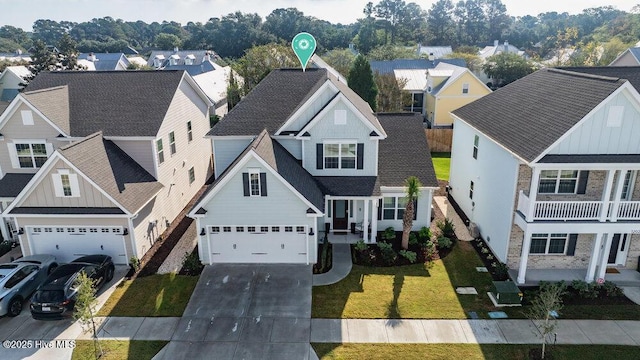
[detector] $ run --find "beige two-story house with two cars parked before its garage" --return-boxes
[0,71,211,264]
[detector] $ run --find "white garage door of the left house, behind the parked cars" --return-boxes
[27,226,127,264]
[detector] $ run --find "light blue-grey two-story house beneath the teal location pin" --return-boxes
[189,69,438,264]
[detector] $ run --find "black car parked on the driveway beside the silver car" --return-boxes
[31,255,115,320]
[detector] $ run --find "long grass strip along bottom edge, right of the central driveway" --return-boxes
[312,343,640,360]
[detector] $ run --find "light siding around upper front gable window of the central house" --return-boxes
[302,101,384,176]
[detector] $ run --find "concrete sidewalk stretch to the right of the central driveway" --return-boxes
[311,319,640,346]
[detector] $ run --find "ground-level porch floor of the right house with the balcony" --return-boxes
[509,268,640,286]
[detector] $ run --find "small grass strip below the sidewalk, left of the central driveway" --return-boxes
[71,340,168,360]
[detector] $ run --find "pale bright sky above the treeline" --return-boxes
[0,0,638,31]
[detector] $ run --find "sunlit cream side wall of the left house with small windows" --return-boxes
[128,80,211,256]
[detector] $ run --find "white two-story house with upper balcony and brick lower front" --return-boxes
[450,68,640,284]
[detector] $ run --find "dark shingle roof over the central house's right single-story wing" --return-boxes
[378,113,438,187]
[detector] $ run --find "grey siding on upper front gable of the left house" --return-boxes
[0,100,69,174]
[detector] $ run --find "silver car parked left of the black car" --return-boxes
[0,255,58,316]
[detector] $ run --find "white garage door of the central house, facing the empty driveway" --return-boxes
[208,225,307,264]
